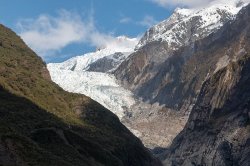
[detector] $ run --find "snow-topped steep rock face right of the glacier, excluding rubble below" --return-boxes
[114,0,247,110]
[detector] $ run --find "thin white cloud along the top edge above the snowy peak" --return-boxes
[151,0,249,8]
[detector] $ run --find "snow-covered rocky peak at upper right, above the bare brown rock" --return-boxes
[136,0,250,50]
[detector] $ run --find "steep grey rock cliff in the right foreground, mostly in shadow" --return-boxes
[165,57,250,166]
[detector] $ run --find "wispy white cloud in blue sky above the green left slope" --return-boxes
[17,10,138,59]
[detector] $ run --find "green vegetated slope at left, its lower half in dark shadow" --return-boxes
[0,25,160,166]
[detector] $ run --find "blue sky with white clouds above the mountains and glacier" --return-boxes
[0,0,229,63]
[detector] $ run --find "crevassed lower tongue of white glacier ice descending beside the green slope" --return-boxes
[48,64,135,118]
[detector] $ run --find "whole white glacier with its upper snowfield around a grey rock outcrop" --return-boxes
[47,36,138,119]
